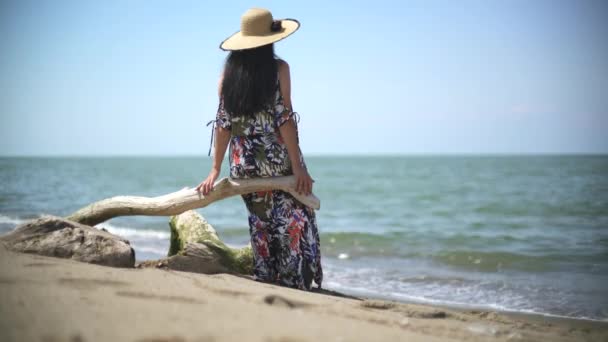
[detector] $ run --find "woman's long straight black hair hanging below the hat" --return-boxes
[222,44,277,116]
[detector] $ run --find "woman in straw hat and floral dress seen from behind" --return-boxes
[197,9,323,290]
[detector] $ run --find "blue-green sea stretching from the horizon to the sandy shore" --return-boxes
[0,155,608,321]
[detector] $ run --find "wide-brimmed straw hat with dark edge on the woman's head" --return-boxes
[220,8,300,51]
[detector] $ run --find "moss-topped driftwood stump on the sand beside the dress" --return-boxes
[138,210,253,275]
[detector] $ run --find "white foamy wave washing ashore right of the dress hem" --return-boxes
[324,262,608,321]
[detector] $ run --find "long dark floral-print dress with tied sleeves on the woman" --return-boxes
[215,72,323,290]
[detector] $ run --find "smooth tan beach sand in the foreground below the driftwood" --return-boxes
[0,244,608,342]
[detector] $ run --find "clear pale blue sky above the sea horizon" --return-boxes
[0,0,608,156]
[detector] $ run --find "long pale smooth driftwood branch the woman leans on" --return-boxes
[66,176,321,226]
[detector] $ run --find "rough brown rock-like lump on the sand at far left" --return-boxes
[0,215,135,267]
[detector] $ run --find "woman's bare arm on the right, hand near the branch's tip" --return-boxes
[279,61,314,195]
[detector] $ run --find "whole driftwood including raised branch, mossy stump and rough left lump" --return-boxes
[0,176,320,275]
